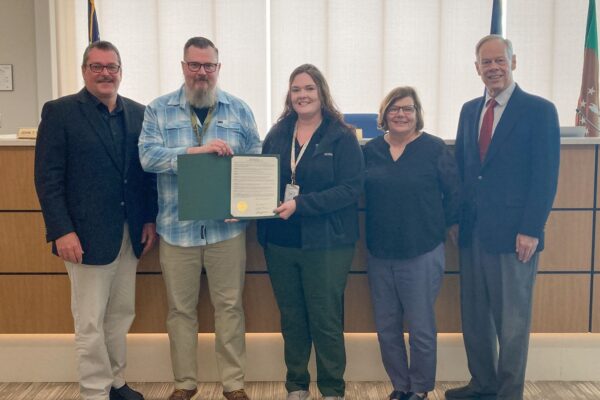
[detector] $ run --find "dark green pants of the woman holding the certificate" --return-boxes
[265,244,354,396]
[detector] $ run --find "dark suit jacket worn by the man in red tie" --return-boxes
[456,86,560,253]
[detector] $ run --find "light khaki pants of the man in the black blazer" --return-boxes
[65,224,138,400]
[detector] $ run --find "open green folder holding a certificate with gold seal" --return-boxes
[177,154,279,221]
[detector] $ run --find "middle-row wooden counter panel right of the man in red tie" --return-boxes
[539,211,593,271]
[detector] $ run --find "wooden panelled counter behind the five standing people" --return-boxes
[0,137,600,334]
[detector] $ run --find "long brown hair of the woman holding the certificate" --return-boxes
[277,64,345,125]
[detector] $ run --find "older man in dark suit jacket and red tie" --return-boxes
[446,35,560,400]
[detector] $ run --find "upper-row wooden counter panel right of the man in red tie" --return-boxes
[553,145,595,208]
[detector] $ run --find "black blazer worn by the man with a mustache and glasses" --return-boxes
[35,89,158,265]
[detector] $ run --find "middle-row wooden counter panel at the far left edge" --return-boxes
[0,212,66,273]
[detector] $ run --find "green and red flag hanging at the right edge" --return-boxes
[575,0,600,136]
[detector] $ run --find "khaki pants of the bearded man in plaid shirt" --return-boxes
[160,233,246,392]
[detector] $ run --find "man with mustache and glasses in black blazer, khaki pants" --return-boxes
[35,41,157,400]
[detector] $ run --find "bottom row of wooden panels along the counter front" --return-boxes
[0,274,584,333]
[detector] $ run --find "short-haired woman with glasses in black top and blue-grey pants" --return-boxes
[364,87,458,400]
